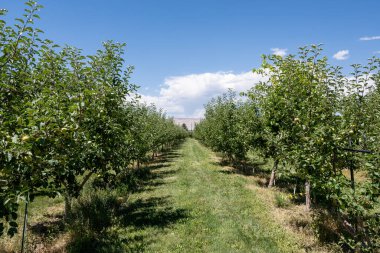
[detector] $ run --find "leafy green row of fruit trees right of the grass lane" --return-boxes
[194,45,380,252]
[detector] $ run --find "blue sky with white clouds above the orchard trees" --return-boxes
[0,0,380,117]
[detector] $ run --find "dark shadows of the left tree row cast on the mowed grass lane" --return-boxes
[113,148,189,252]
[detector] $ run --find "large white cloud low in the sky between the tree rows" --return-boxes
[141,71,266,118]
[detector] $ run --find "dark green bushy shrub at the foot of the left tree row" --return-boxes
[67,185,125,252]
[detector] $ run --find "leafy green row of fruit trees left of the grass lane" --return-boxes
[0,1,187,235]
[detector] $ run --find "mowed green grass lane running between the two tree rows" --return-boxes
[129,139,301,252]
